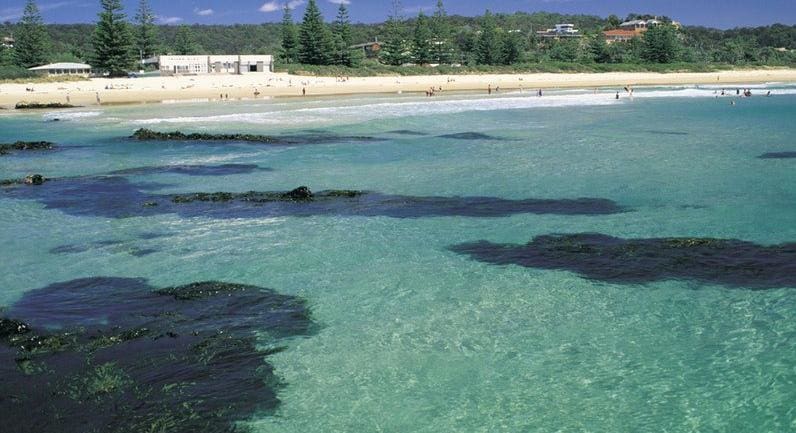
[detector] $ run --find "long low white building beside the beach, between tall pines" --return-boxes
[158,55,274,75]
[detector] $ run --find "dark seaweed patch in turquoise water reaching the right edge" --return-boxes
[451,233,796,289]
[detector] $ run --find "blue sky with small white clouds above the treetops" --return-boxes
[0,0,796,29]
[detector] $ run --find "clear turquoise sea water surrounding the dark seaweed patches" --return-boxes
[0,85,796,432]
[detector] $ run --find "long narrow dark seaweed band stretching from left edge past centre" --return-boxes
[3,176,624,219]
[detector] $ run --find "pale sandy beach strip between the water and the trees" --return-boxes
[0,69,796,109]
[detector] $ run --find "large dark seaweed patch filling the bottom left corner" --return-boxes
[0,278,312,433]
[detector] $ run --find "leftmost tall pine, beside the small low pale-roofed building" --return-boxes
[14,0,50,68]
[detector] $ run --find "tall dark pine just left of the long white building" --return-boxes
[93,0,134,77]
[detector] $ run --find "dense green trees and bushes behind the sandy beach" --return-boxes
[0,0,796,79]
